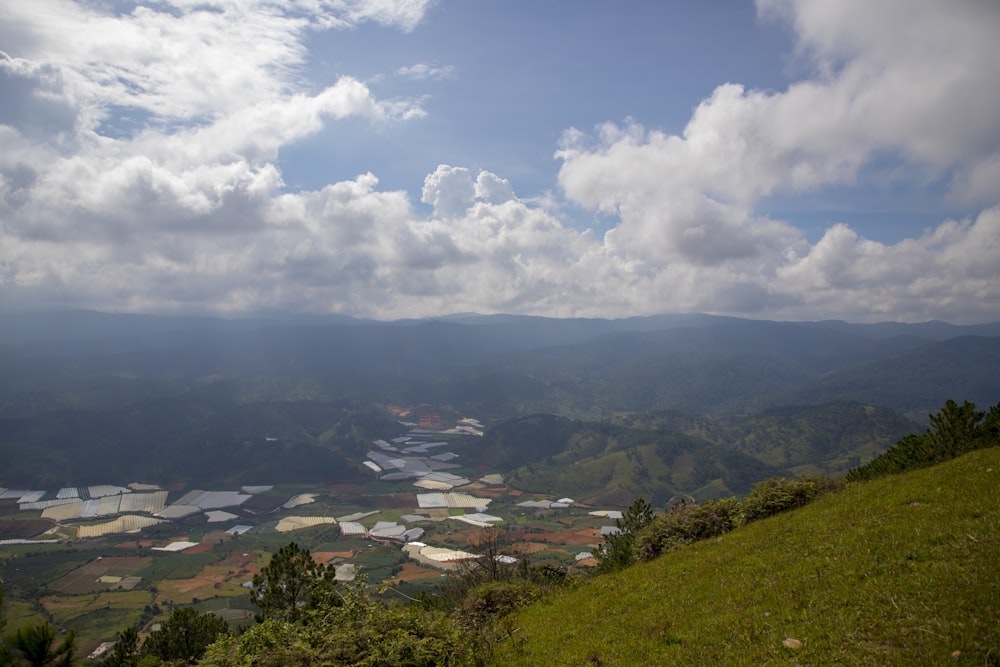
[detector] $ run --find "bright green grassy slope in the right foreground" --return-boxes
[496,447,1000,666]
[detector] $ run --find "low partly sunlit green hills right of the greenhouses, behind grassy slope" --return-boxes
[500,403,915,506]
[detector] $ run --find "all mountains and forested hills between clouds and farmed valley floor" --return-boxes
[0,312,1000,488]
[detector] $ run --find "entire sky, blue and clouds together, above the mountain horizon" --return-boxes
[0,0,1000,323]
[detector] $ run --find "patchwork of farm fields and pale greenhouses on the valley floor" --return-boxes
[0,422,614,652]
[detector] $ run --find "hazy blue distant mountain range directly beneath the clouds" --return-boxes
[0,311,1000,418]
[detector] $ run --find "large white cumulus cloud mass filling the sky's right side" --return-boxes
[557,0,1000,318]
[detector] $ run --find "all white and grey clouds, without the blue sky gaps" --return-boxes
[0,0,1000,322]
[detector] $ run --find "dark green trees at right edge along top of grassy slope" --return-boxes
[847,400,1000,482]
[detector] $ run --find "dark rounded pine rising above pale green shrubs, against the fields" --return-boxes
[250,542,339,623]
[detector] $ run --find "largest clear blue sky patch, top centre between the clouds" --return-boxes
[280,0,792,207]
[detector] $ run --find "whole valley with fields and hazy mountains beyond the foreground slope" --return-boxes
[0,313,1000,654]
